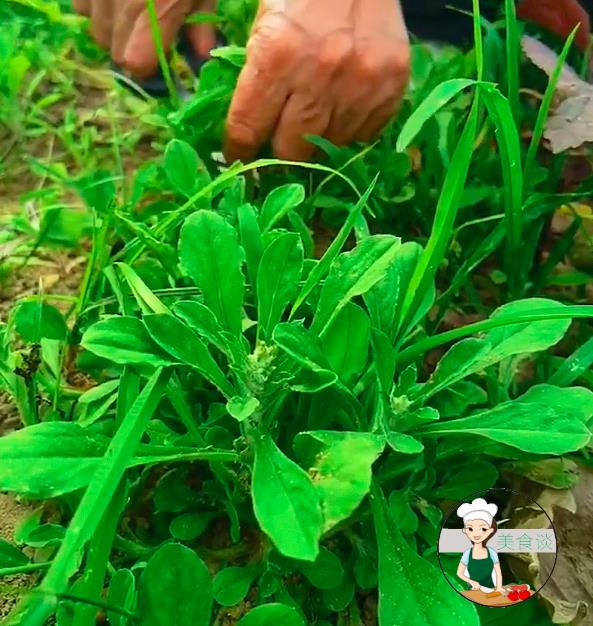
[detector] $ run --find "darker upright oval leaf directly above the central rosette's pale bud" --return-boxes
[257,233,304,339]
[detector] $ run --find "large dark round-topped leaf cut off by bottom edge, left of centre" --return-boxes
[138,543,212,626]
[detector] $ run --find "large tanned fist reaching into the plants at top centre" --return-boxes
[224,0,410,162]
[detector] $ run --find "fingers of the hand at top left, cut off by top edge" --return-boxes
[74,0,216,78]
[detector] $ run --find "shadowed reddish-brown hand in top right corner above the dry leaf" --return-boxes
[517,0,591,50]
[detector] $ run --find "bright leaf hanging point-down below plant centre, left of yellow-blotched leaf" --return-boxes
[251,436,323,561]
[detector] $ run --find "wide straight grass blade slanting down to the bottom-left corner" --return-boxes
[6,368,169,626]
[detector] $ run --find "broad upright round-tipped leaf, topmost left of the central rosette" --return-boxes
[179,211,245,336]
